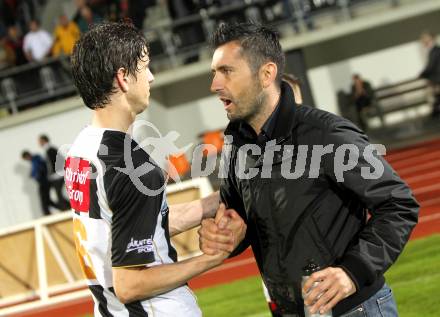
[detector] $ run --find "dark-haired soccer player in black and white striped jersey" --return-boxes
[65,23,246,317]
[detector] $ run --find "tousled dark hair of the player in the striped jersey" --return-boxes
[71,22,148,109]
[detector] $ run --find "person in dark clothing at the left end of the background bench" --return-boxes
[351,74,374,130]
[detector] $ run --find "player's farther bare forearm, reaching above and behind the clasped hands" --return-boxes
[169,191,220,236]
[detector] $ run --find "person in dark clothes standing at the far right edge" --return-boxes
[420,31,440,117]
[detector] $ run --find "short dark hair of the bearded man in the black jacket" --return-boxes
[211,22,286,85]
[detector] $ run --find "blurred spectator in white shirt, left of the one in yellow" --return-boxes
[23,20,53,62]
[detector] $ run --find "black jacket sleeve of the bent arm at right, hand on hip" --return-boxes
[323,120,419,289]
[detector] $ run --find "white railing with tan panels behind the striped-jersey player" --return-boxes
[0,178,212,316]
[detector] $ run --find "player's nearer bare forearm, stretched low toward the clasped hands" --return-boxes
[113,254,223,304]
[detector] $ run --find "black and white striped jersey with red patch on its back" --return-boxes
[65,127,201,317]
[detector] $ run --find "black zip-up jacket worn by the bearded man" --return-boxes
[220,83,419,316]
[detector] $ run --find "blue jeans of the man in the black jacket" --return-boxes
[341,284,399,317]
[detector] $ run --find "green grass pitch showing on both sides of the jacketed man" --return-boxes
[196,235,440,317]
